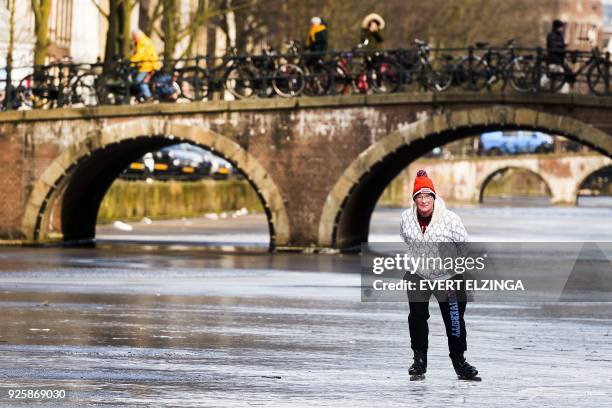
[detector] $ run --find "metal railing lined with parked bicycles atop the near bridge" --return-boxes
[0,40,612,110]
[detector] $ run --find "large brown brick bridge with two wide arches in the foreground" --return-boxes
[0,93,612,248]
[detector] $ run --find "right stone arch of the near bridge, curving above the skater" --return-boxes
[318,105,612,249]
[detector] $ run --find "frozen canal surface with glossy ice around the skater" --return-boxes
[0,208,612,407]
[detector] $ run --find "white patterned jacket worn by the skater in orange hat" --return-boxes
[400,196,468,279]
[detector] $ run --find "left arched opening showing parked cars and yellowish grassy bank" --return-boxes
[96,143,270,250]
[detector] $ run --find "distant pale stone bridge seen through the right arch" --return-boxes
[402,152,612,205]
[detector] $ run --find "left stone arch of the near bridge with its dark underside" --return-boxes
[22,118,290,248]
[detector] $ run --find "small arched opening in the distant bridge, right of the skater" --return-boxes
[478,166,552,207]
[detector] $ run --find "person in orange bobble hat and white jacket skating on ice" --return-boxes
[400,170,480,380]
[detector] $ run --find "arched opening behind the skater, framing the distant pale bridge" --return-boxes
[368,137,612,242]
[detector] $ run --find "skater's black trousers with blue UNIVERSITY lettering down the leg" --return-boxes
[406,274,467,354]
